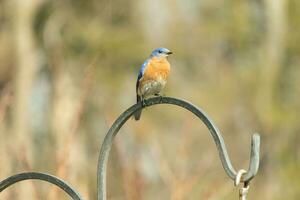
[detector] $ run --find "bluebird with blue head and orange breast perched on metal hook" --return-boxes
[134,47,173,121]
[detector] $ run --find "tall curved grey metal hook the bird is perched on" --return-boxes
[97,97,260,200]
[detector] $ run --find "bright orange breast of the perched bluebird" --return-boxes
[143,58,170,81]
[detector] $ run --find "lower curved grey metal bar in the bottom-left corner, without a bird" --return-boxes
[0,172,83,200]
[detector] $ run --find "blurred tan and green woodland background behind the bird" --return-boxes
[0,0,300,200]
